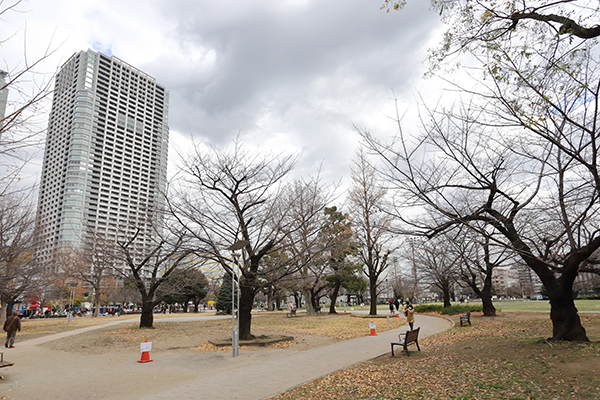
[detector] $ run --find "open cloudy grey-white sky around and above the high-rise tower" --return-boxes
[0,0,442,193]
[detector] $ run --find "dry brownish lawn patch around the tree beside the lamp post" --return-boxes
[44,312,406,354]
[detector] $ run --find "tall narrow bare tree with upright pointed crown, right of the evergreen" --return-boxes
[349,148,397,315]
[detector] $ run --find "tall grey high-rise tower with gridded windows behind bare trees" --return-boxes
[36,50,169,263]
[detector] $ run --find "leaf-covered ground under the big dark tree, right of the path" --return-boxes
[270,313,600,400]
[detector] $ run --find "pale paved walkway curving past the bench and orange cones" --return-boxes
[0,315,451,400]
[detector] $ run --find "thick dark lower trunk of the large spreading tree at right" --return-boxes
[548,288,590,342]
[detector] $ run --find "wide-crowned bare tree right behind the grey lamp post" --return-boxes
[171,141,299,340]
